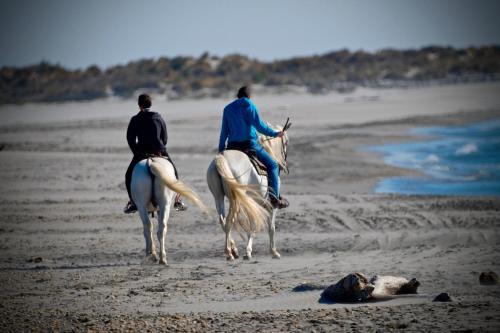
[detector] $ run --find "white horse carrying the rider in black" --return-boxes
[131,157,207,265]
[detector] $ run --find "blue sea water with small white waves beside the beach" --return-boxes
[367,119,500,195]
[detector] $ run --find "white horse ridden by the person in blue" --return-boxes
[207,124,288,260]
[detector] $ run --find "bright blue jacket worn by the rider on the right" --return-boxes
[219,97,278,152]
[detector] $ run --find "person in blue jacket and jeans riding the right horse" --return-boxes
[219,86,289,208]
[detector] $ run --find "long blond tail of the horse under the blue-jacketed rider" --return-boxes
[215,154,269,233]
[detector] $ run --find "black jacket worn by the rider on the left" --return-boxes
[127,111,167,155]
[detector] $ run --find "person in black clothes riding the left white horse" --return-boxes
[124,94,186,214]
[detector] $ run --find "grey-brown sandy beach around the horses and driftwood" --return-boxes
[0,83,500,332]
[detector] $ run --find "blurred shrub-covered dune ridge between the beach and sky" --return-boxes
[0,46,500,104]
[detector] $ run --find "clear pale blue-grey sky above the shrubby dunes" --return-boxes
[0,0,500,68]
